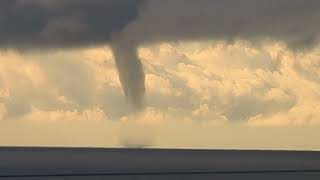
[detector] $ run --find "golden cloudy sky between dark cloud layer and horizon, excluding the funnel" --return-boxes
[0,41,320,150]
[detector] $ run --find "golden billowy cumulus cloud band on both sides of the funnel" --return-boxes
[1,41,319,122]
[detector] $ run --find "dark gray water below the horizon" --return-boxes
[0,148,320,180]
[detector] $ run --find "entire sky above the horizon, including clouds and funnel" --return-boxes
[0,0,320,150]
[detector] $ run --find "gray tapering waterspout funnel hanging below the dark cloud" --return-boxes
[112,41,145,111]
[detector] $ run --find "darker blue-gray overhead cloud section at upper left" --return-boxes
[0,0,140,48]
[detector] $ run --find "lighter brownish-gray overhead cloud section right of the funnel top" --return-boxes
[126,0,320,47]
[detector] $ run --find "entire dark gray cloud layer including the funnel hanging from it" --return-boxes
[0,0,320,108]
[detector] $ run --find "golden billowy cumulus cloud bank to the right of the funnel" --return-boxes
[141,41,318,126]
